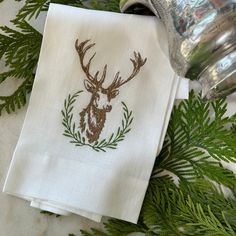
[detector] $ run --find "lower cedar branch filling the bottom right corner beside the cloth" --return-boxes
[82,177,236,236]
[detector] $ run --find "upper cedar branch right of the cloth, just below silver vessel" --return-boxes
[153,91,236,188]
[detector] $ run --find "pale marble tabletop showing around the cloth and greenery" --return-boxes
[0,0,236,236]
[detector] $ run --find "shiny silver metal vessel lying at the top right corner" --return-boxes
[120,0,236,100]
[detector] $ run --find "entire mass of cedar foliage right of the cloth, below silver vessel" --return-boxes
[81,91,236,236]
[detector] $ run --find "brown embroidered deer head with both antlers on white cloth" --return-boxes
[75,39,147,143]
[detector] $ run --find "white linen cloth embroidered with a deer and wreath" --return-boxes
[4,4,187,223]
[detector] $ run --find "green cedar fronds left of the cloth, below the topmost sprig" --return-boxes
[0,21,42,115]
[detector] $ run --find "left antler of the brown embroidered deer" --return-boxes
[75,39,107,85]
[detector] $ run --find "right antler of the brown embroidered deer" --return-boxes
[107,52,147,90]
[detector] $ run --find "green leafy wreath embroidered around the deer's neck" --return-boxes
[61,90,133,152]
